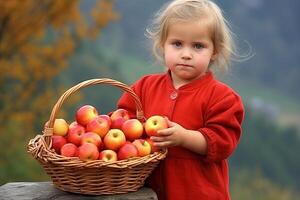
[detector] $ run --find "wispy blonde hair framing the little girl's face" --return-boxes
[146,0,234,71]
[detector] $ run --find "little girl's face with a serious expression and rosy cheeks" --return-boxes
[163,21,215,87]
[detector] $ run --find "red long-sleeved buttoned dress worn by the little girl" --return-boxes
[118,72,244,200]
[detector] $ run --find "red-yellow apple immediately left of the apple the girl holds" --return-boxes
[122,119,144,141]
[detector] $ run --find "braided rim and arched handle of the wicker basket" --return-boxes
[27,78,167,168]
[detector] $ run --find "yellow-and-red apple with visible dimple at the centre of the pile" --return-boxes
[103,129,126,151]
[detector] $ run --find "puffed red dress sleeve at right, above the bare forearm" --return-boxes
[199,89,244,161]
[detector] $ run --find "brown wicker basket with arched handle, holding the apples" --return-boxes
[28,79,167,195]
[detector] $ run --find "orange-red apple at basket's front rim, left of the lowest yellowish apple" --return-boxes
[78,143,99,160]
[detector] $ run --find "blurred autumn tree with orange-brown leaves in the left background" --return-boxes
[0,0,118,184]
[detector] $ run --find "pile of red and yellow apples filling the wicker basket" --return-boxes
[47,105,168,161]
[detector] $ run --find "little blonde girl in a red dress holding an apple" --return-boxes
[118,0,244,200]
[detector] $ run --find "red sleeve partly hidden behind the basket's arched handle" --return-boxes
[117,77,142,118]
